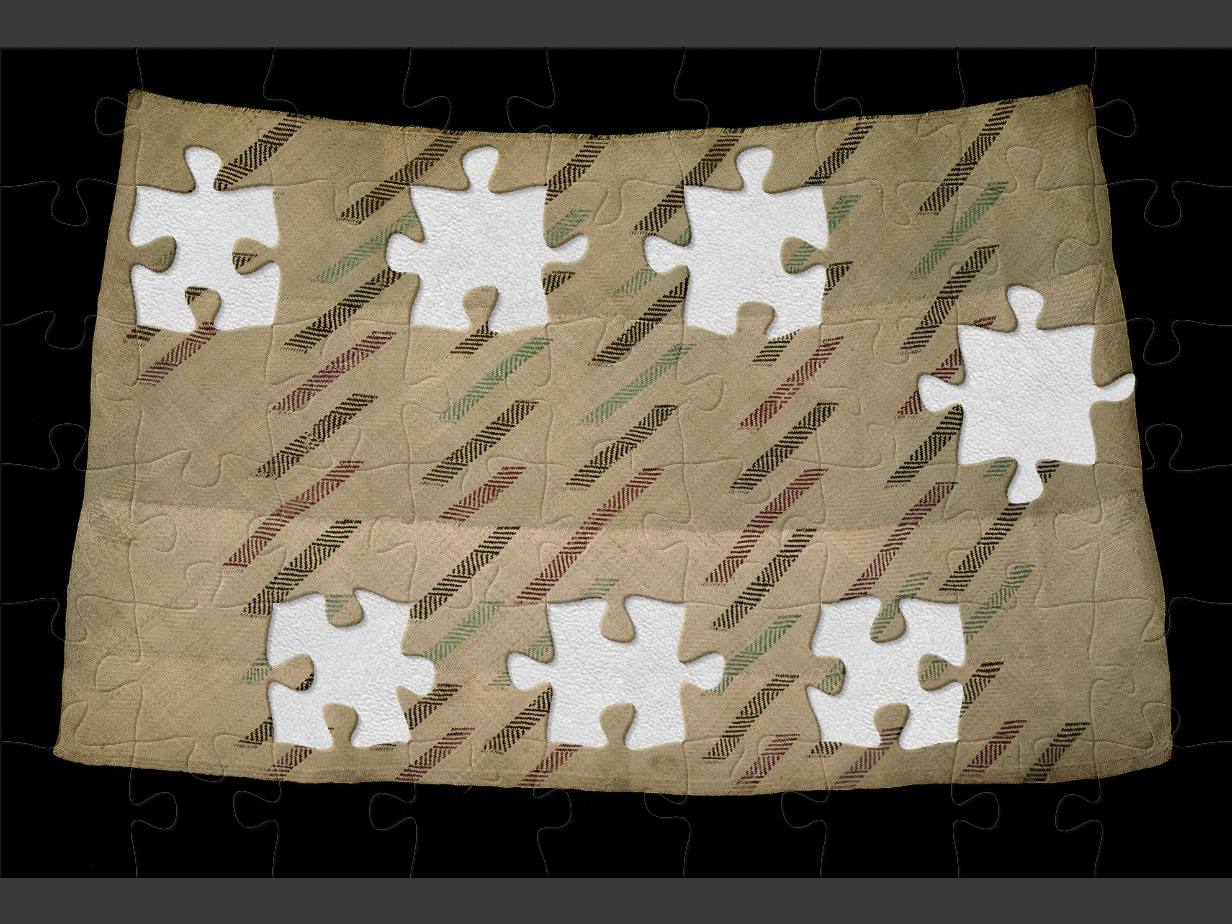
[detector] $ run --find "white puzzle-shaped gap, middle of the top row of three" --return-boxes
[386,147,586,333]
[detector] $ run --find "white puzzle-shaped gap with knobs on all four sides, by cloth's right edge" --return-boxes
[919,286,1135,504]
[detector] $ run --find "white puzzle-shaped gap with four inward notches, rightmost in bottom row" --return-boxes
[808,596,966,749]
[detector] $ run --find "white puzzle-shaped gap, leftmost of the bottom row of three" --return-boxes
[266,590,435,748]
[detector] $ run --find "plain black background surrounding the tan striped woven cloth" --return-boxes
[0,49,1232,876]
